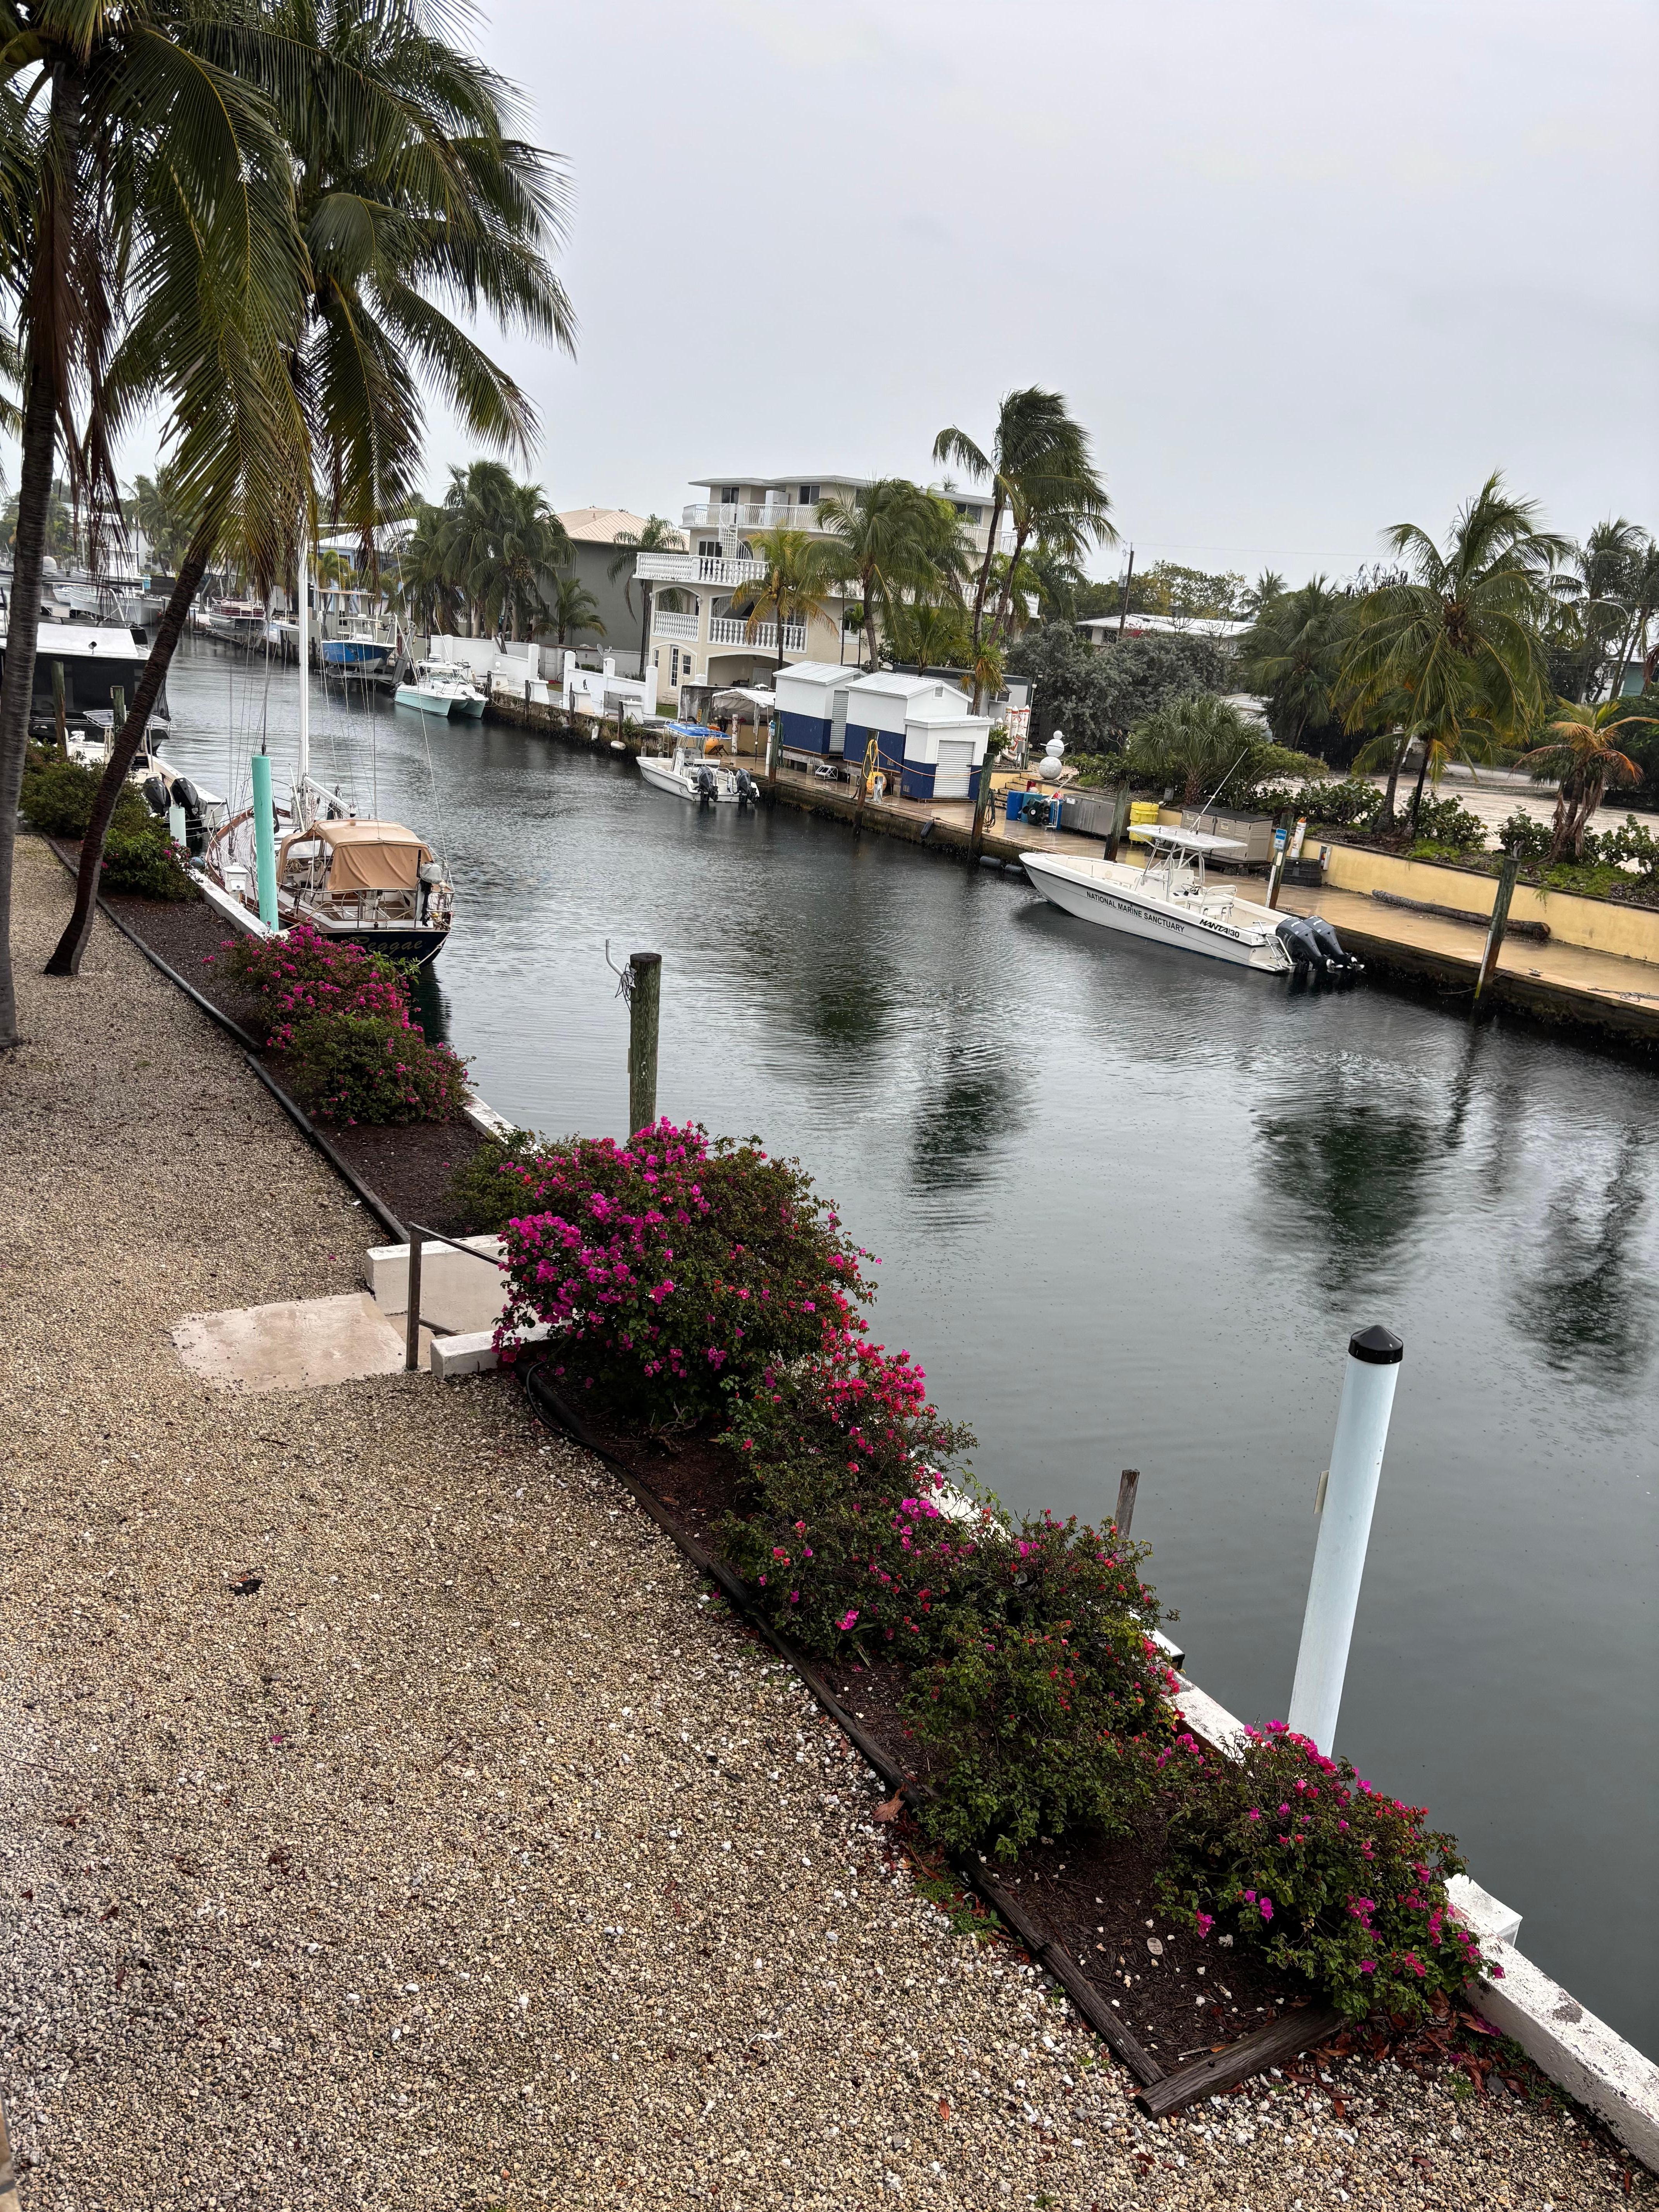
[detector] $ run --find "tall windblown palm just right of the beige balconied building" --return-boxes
[933,385,1117,714]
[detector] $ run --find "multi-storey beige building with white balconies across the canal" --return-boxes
[635,473,1022,712]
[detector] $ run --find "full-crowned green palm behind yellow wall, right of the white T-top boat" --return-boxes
[1340,471,1566,832]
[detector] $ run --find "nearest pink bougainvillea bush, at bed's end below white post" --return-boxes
[1161,1721,1502,2022]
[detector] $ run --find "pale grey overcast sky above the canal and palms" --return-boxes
[13,0,1659,580]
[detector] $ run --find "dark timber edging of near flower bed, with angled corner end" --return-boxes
[524,1363,1343,2119]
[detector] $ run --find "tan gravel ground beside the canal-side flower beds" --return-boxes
[0,838,1655,2212]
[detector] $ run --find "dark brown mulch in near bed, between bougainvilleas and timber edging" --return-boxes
[526,1391,1316,2073]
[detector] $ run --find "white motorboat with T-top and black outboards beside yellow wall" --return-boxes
[1020,823,1358,975]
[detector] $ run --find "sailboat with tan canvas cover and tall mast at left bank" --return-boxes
[201,549,453,967]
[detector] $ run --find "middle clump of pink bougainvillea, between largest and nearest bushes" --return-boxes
[723,1336,1172,1856]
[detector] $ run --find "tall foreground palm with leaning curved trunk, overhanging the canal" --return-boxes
[42,0,573,971]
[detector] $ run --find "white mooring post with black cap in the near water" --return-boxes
[1290,1329,1405,1759]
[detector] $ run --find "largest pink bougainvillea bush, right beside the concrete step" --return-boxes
[500,1121,869,1427]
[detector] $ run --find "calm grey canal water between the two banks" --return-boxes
[159,646,1659,2053]
